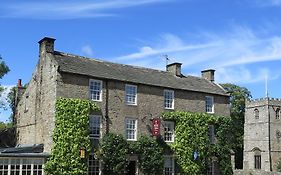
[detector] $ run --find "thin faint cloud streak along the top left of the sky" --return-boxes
[0,0,171,19]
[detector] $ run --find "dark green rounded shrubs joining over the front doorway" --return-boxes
[98,133,164,175]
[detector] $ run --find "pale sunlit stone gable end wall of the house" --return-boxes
[15,53,57,152]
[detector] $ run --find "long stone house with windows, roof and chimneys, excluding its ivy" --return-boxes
[2,37,230,175]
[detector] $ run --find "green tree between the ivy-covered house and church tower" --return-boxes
[221,83,252,169]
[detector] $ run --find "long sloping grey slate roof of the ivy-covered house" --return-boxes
[54,51,229,96]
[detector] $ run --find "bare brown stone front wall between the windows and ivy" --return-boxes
[57,73,230,139]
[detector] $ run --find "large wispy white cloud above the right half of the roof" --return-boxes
[111,26,281,83]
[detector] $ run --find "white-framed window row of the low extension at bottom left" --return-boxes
[0,158,44,175]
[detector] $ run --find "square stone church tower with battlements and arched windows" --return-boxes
[244,98,281,171]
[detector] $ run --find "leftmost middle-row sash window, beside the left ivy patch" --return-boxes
[90,115,101,139]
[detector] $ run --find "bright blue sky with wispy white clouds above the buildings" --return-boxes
[0,0,281,121]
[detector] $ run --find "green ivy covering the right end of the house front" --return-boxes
[163,112,233,175]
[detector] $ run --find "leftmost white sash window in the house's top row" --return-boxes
[90,79,102,101]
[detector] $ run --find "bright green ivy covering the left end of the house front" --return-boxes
[45,98,98,175]
